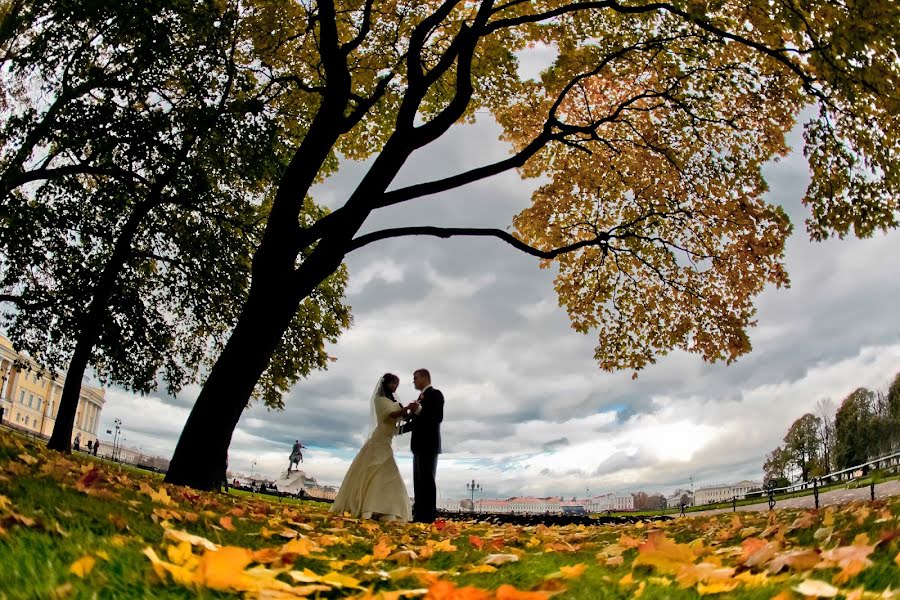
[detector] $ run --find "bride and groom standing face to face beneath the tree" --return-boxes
[331,369,444,523]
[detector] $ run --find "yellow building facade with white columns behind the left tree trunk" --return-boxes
[0,335,106,448]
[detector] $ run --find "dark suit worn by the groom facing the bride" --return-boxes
[409,387,444,523]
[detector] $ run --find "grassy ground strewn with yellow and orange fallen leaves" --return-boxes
[0,431,900,600]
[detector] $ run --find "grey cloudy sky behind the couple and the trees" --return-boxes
[93,50,900,498]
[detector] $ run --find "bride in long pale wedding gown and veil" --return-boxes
[331,373,412,521]
